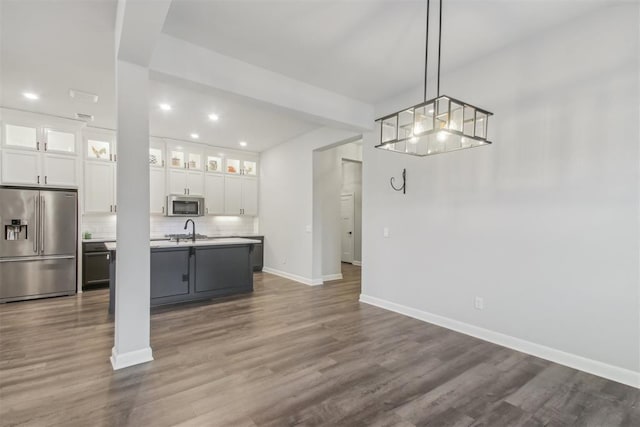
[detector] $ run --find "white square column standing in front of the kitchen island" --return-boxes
[111,60,153,369]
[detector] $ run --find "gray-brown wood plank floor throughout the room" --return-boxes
[0,265,640,427]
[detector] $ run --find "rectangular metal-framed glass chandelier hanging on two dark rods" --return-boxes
[376,0,493,156]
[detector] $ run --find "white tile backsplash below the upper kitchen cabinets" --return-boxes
[81,214,258,239]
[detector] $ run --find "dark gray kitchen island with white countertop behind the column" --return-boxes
[105,238,261,312]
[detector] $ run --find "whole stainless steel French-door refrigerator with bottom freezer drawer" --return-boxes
[0,187,78,302]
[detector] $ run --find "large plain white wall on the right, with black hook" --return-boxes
[362,3,640,383]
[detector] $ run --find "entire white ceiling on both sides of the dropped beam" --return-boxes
[0,0,615,151]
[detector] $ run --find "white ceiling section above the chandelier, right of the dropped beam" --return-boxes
[163,0,610,103]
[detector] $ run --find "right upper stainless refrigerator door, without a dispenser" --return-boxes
[39,191,78,255]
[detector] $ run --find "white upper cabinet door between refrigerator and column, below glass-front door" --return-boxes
[84,162,116,213]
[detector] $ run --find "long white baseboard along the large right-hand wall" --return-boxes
[360,294,640,388]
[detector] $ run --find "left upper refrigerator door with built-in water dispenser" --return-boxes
[0,188,39,258]
